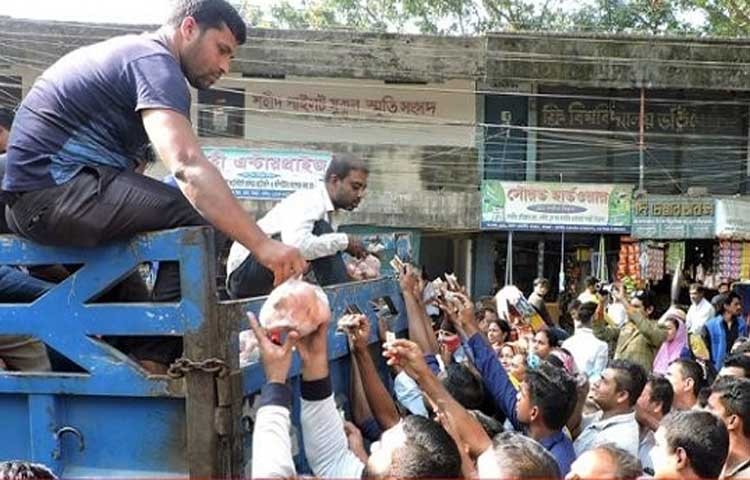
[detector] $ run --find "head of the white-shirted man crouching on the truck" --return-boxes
[326,154,370,210]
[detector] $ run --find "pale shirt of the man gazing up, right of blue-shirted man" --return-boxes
[573,412,640,458]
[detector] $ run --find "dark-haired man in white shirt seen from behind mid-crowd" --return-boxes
[562,302,609,382]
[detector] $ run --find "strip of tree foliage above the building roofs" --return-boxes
[251,0,750,36]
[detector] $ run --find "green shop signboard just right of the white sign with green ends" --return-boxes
[631,195,715,240]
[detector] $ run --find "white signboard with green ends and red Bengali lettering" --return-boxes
[481,180,633,233]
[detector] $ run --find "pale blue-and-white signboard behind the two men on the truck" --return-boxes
[203,147,331,200]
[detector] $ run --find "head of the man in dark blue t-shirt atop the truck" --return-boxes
[165,0,247,89]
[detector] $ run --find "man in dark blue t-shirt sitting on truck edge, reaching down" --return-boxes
[2,0,306,372]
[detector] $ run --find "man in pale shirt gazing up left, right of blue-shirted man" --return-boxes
[572,360,646,457]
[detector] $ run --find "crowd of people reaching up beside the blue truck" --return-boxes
[251,266,750,479]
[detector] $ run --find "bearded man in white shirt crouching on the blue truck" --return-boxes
[227,154,368,298]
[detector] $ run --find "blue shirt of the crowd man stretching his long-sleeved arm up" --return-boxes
[468,333,576,475]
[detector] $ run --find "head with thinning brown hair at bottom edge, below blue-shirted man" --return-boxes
[488,432,561,480]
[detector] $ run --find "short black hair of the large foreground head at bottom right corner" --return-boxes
[660,410,729,478]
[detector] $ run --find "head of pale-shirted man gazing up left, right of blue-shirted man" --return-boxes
[591,360,646,412]
